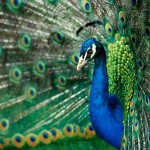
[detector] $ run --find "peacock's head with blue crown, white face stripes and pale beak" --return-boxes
[77,38,101,70]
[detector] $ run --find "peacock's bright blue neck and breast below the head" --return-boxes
[90,47,124,148]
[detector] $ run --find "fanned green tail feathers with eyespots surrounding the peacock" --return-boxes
[0,0,150,150]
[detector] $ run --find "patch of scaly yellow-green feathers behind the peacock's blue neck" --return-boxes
[107,40,135,123]
